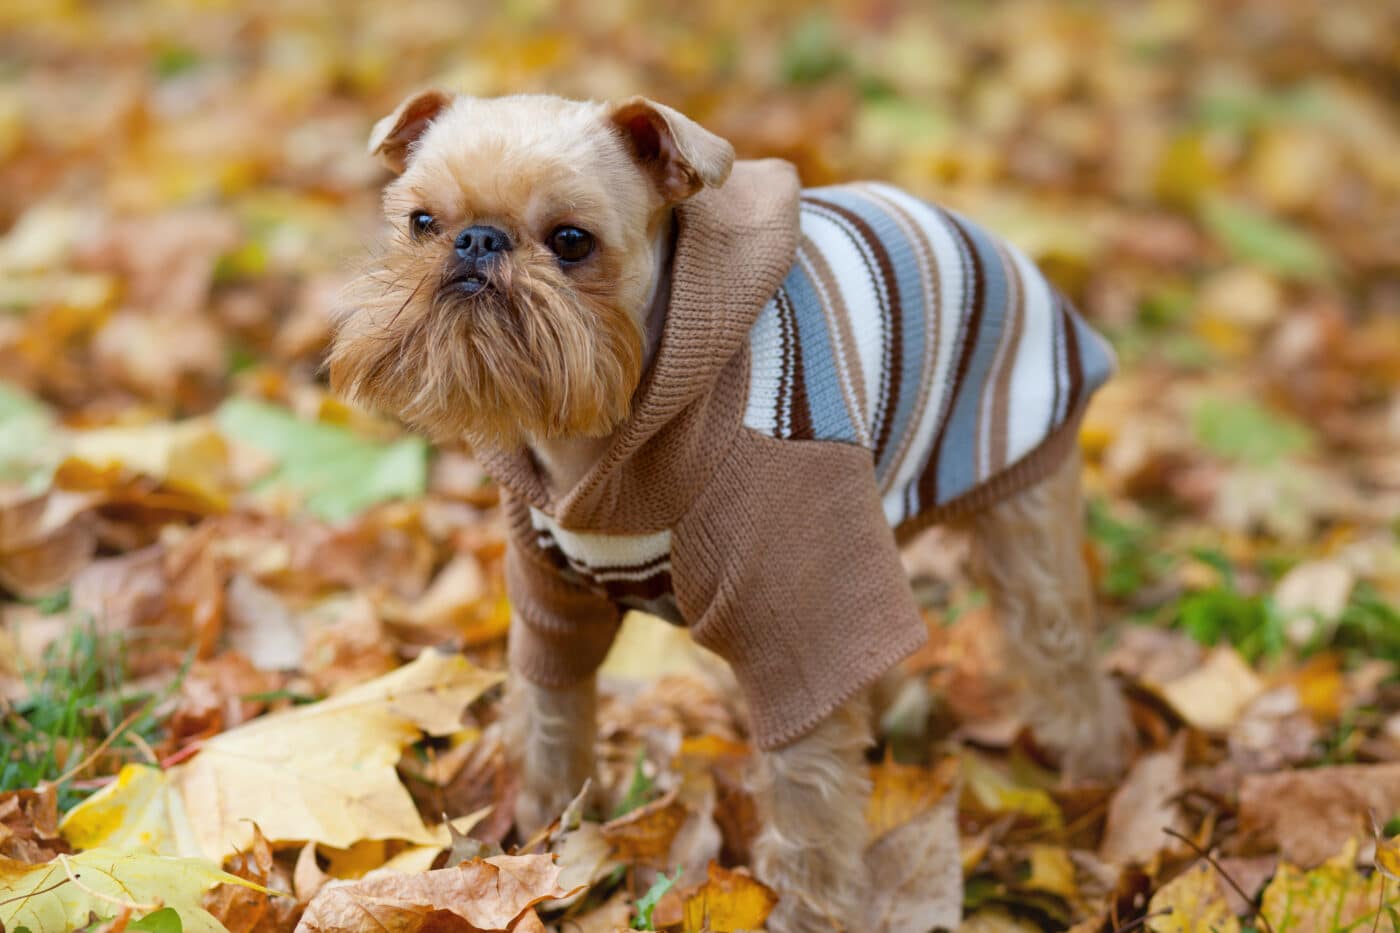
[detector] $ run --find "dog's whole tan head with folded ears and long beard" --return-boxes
[329,91,734,445]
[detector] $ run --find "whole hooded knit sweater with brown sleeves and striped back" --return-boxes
[479,161,1112,748]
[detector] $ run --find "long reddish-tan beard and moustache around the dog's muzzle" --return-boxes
[328,250,643,447]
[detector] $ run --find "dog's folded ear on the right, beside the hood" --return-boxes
[608,97,734,203]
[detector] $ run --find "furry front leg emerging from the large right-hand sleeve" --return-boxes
[755,695,871,933]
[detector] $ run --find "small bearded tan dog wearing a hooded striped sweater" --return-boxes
[328,90,1128,933]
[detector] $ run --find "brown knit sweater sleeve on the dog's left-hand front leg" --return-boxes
[505,497,622,686]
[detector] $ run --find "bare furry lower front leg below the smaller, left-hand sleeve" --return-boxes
[505,664,598,836]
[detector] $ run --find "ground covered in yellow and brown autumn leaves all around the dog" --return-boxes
[0,0,1400,933]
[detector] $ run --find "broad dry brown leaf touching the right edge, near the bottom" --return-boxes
[1239,763,1400,869]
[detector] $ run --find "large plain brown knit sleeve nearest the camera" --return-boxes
[672,429,927,748]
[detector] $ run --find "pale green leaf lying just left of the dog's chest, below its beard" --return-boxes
[216,398,428,521]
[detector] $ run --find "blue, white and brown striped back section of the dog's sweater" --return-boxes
[743,184,1113,528]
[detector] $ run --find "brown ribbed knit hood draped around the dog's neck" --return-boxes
[476,160,799,532]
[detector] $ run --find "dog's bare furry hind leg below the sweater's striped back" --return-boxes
[972,451,1131,782]
